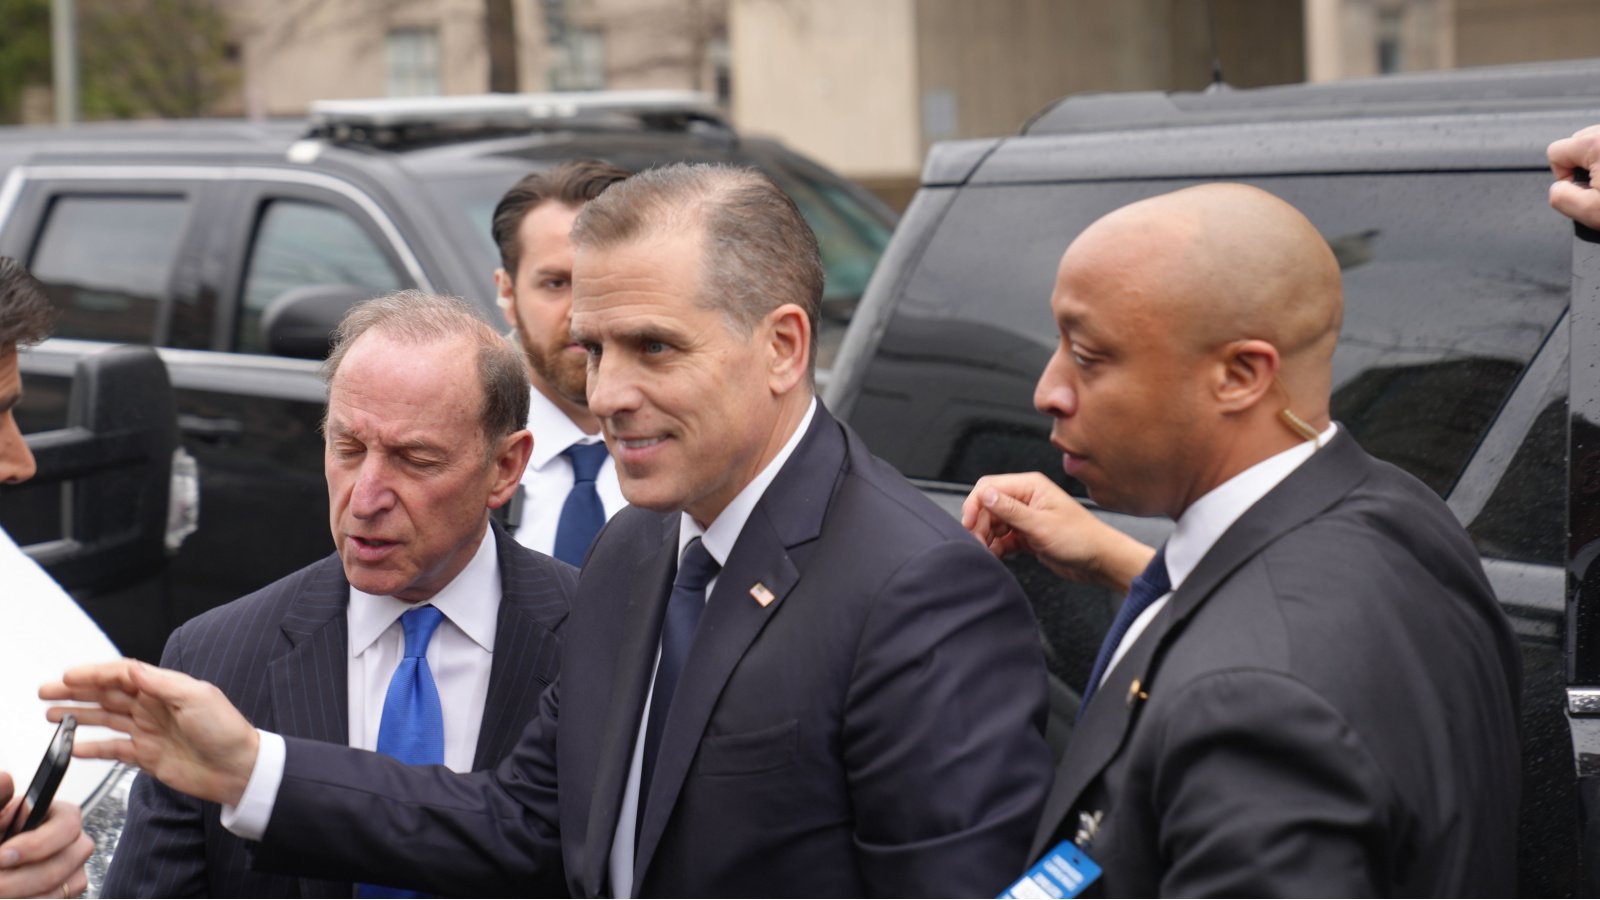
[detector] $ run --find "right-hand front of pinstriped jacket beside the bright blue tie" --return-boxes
[472,520,566,770]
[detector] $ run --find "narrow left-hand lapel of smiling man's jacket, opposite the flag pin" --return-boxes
[584,516,678,897]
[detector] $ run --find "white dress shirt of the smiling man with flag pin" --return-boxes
[610,397,816,900]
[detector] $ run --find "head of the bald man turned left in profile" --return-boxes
[1035,184,1342,516]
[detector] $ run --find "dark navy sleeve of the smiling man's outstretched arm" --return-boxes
[256,666,566,897]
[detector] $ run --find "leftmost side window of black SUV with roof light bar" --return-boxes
[29,194,189,344]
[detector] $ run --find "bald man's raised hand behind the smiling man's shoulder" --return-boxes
[962,472,1155,593]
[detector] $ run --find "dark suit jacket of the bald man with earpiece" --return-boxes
[1034,431,1522,897]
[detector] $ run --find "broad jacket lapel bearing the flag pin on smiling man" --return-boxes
[634,402,845,897]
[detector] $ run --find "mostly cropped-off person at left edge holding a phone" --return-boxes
[0,256,94,897]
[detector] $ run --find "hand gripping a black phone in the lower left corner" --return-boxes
[0,772,94,897]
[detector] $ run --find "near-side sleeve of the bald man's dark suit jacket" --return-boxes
[1150,669,1402,897]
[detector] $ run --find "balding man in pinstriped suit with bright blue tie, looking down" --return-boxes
[104,291,576,897]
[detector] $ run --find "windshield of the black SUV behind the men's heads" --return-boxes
[427,153,894,370]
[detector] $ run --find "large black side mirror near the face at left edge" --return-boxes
[24,346,178,591]
